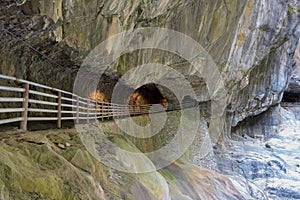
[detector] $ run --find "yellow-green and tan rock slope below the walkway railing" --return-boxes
[0,113,256,200]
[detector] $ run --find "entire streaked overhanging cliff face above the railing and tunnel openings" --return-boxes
[0,0,300,134]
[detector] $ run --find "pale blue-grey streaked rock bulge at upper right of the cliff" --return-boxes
[227,1,300,124]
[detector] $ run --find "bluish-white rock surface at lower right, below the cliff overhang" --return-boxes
[215,105,300,200]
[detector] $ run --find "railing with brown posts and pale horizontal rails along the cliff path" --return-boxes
[0,74,171,130]
